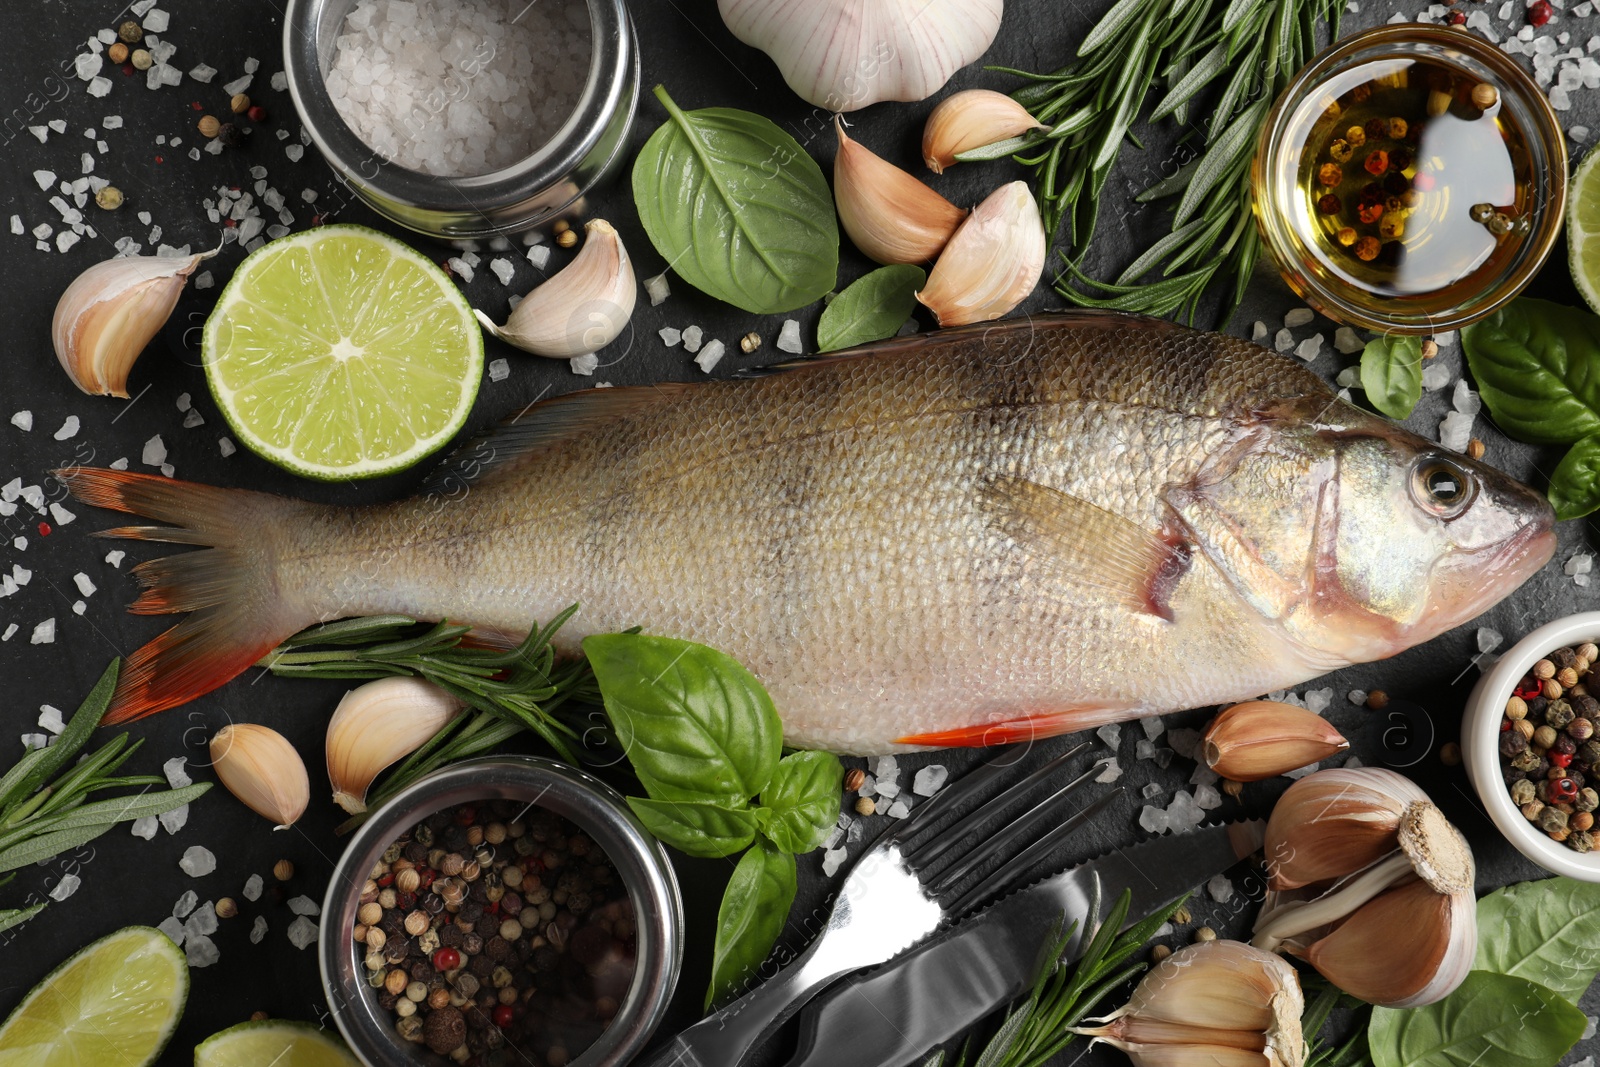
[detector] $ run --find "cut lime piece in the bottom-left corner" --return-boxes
[0,926,189,1067]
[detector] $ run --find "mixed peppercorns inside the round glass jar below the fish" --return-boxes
[354,800,635,1067]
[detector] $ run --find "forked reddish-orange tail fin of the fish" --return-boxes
[54,467,315,725]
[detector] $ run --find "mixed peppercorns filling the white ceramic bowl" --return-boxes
[1499,645,1600,853]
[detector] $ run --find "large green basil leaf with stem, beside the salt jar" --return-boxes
[634,85,838,315]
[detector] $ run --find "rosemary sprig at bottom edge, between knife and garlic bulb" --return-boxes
[922,885,1187,1067]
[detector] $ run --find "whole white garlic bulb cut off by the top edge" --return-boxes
[717,0,1005,112]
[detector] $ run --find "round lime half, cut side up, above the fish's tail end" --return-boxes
[202,226,483,480]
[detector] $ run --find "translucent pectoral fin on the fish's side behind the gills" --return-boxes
[984,478,1192,622]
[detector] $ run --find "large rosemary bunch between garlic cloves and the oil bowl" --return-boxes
[979,0,1344,322]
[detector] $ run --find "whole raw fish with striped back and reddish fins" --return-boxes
[66,314,1549,752]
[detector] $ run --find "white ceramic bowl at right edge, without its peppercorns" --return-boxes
[1461,611,1600,881]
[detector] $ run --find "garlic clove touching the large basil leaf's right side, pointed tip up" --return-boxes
[834,118,966,266]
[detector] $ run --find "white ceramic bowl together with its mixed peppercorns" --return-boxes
[1461,611,1600,881]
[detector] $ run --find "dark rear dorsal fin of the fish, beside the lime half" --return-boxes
[419,382,706,496]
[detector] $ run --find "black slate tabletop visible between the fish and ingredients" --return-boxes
[0,0,1600,1064]
